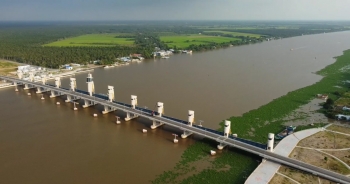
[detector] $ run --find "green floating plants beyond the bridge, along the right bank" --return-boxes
[220,50,350,143]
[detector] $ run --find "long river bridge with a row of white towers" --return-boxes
[0,74,350,183]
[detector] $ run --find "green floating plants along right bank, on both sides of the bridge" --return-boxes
[153,50,350,183]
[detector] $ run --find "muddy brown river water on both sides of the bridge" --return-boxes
[0,32,350,183]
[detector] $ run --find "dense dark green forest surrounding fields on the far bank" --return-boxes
[0,21,350,68]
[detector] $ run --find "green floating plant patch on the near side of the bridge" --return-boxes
[151,139,260,184]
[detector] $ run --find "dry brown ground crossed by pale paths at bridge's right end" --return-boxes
[266,124,350,184]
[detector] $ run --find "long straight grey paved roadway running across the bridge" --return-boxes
[0,76,350,184]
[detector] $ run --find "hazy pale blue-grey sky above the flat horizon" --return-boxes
[0,0,350,21]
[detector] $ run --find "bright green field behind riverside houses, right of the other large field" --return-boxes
[160,34,240,48]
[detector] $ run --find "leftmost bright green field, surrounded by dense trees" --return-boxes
[44,33,134,47]
